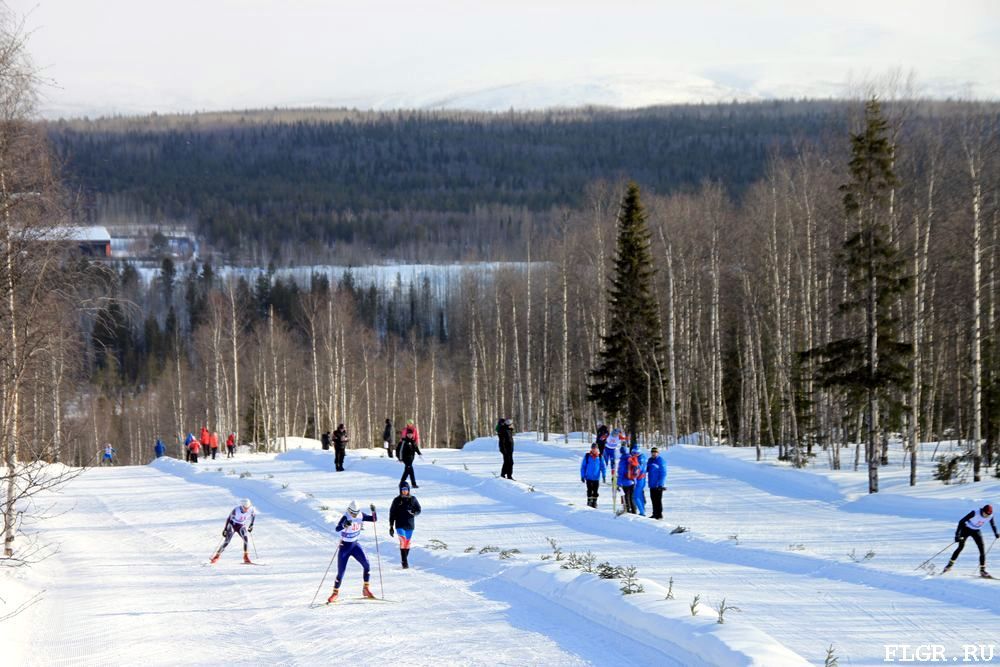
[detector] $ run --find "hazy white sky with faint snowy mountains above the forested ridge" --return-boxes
[6,0,1000,117]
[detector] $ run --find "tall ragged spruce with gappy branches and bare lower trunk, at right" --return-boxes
[811,99,913,493]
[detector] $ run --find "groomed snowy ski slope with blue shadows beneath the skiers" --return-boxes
[0,434,1000,667]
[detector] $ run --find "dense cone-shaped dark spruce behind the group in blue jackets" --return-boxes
[589,183,663,444]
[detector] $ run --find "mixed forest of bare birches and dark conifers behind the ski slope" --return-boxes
[5,95,1000,498]
